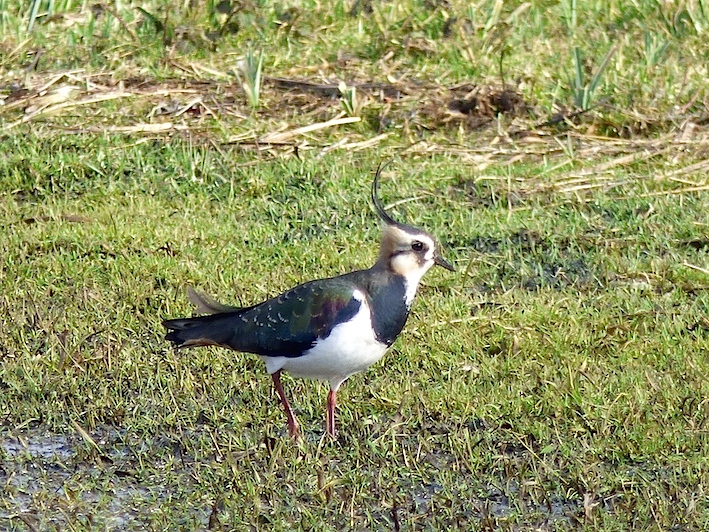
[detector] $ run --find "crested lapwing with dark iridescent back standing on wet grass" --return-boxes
[162,164,455,440]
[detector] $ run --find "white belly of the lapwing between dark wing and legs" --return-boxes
[261,296,387,390]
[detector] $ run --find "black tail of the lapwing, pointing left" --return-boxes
[162,312,239,347]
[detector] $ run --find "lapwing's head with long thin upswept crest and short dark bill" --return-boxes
[372,164,455,284]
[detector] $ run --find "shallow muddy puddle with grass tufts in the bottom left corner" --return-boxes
[0,429,210,530]
